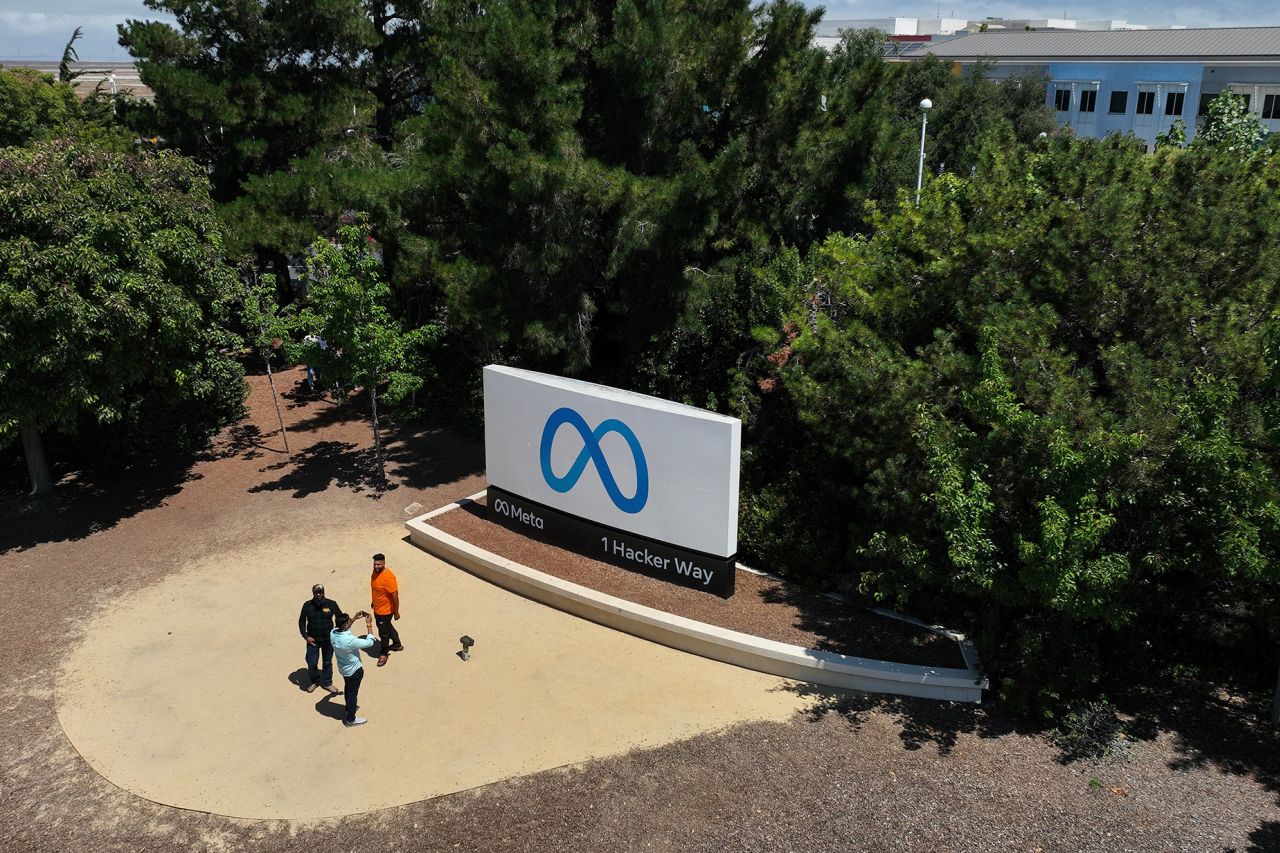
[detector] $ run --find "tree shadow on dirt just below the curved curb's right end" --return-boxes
[785,683,1033,756]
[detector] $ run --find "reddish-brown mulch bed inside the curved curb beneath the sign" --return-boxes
[431,498,965,670]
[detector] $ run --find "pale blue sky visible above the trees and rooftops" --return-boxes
[0,0,1280,61]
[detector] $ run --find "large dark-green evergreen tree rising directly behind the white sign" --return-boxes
[392,0,916,379]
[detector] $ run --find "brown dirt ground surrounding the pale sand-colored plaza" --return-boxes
[0,361,1280,853]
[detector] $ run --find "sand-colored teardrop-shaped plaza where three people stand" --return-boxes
[56,524,804,820]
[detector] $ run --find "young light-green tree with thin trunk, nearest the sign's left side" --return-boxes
[298,224,436,479]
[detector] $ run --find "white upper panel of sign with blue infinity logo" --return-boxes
[484,365,742,557]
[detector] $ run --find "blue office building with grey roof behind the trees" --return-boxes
[902,27,1280,146]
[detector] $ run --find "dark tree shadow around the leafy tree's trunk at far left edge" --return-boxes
[0,438,201,553]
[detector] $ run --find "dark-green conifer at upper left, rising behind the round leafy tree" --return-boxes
[119,0,367,200]
